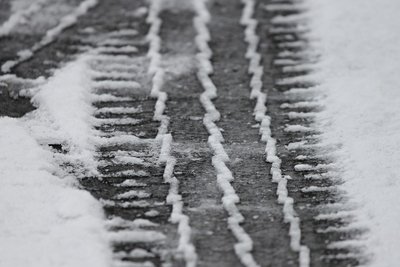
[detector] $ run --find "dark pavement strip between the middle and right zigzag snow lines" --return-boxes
[200,0,307,266]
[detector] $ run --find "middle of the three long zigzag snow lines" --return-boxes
[193,0,259,267]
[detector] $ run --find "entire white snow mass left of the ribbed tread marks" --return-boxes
[0,56,111,267]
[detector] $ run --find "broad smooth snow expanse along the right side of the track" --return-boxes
[306,0,400,267]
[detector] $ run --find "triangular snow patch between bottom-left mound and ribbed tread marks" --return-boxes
[26,56,97,174]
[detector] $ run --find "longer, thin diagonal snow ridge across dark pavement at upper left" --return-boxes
[1,0,98,73]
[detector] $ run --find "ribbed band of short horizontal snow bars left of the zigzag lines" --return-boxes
[82,27,177,266]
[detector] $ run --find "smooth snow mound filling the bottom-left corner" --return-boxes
[0,117,111,267]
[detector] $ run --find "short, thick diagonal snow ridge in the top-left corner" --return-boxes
[0,0,48,37]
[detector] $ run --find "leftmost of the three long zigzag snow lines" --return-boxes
[147,0,197,267]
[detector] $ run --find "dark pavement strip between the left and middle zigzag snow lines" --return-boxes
[160,2,241,267]
